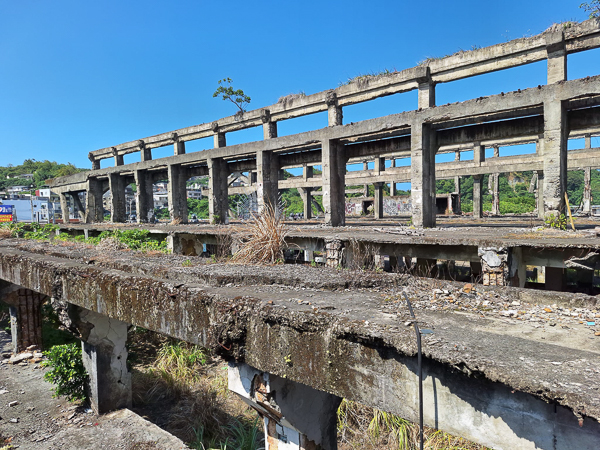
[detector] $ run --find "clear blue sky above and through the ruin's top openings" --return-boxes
[0,0,600,172]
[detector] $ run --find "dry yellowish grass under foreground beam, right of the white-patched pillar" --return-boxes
[337,399,489,450]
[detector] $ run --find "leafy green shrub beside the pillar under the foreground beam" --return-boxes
[42,342,89,402]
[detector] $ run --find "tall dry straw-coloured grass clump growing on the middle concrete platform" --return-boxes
[231,204,288,264]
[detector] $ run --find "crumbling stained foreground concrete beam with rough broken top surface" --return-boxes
[0,240,600,449]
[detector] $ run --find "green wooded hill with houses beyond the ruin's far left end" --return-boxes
[0,159,87,191]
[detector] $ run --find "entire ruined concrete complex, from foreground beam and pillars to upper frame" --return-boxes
[0,19,600,450]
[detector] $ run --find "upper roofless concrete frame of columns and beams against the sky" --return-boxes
[50,19,600,227]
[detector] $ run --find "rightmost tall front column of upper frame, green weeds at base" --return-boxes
[543,101,568,215]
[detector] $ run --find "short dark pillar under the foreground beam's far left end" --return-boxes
[0,283,46,353]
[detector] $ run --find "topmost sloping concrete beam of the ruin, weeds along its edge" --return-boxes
[89,19,600,160]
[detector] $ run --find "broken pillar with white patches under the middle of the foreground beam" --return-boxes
[228,363,342,450]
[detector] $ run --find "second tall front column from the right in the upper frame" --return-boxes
[410,123,436,228]
